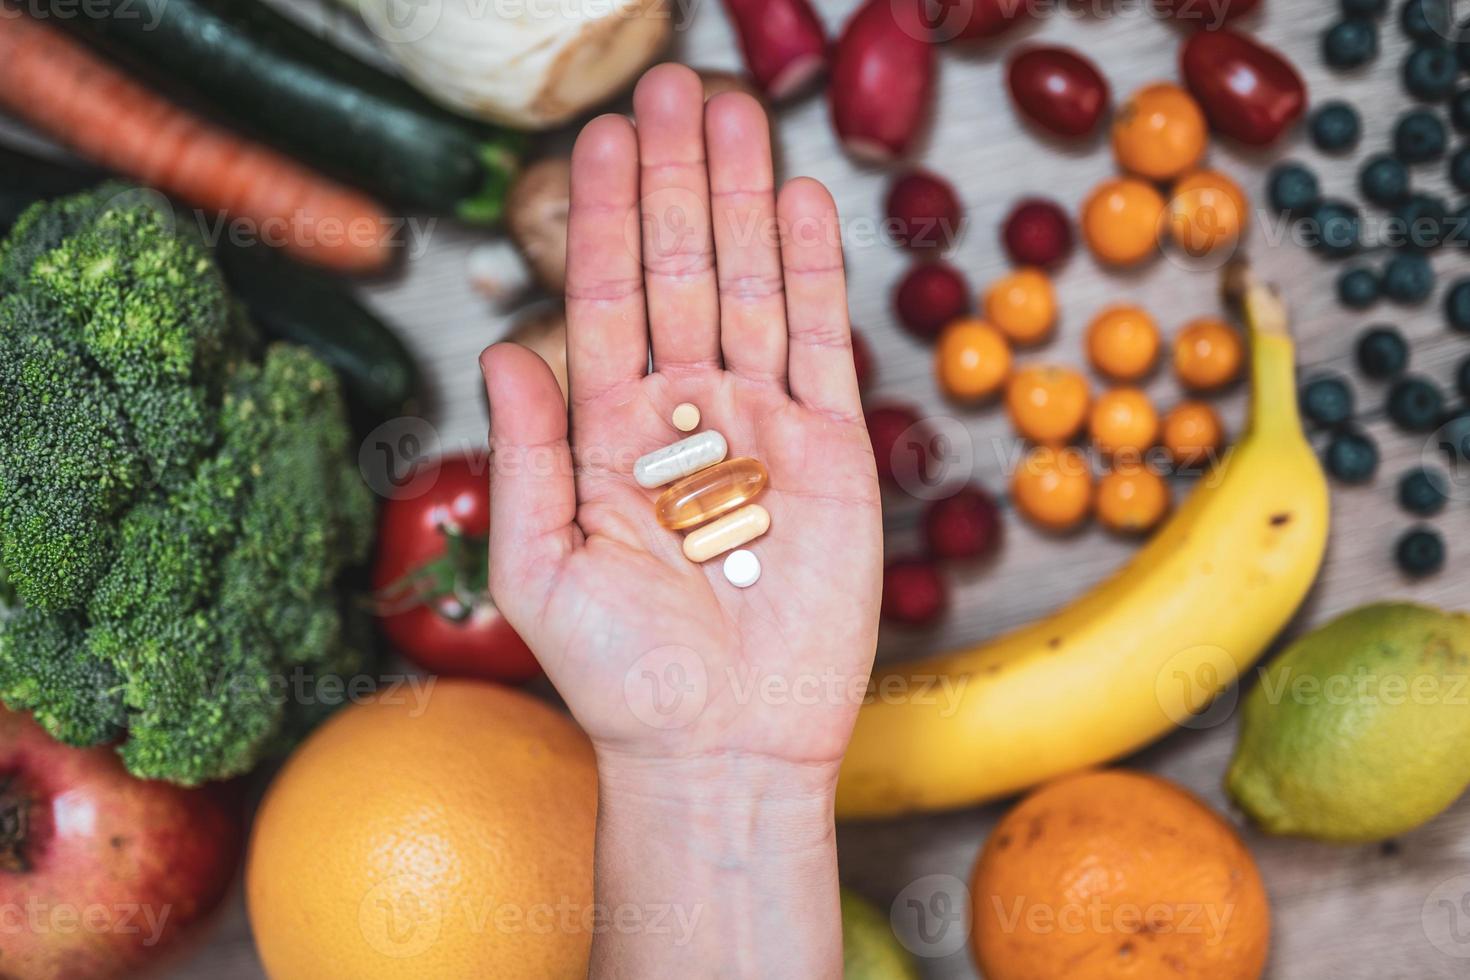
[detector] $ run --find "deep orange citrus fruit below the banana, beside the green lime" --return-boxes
[970,770,1270,980]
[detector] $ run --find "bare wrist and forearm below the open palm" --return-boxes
[591,754,842,980]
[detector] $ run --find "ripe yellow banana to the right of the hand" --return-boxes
[836,282,1329,818]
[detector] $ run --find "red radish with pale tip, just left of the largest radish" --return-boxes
[725,0,828,98]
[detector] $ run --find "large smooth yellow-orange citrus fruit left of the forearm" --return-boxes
[245,679,597,980]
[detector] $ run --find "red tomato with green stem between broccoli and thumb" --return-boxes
[373,455,541,683]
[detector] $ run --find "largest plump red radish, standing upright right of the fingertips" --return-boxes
[828,0,933,162]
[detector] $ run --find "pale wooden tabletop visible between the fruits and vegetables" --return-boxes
[54,0,1470,980]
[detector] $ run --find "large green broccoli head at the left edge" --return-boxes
[0,185,372,785]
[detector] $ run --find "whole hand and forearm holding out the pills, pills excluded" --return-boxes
[481,65,882,977]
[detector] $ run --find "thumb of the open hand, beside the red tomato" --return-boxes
[479,344,582,625]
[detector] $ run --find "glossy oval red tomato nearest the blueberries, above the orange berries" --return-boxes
[1179,31,1307,147]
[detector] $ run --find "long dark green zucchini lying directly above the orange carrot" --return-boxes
[43,0,523,225]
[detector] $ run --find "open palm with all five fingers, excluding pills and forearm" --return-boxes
[482,65,882,771]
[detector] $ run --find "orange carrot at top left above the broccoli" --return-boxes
[0,8,394,272]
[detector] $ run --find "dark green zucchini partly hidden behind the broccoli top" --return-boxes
[0,143,419,428]
